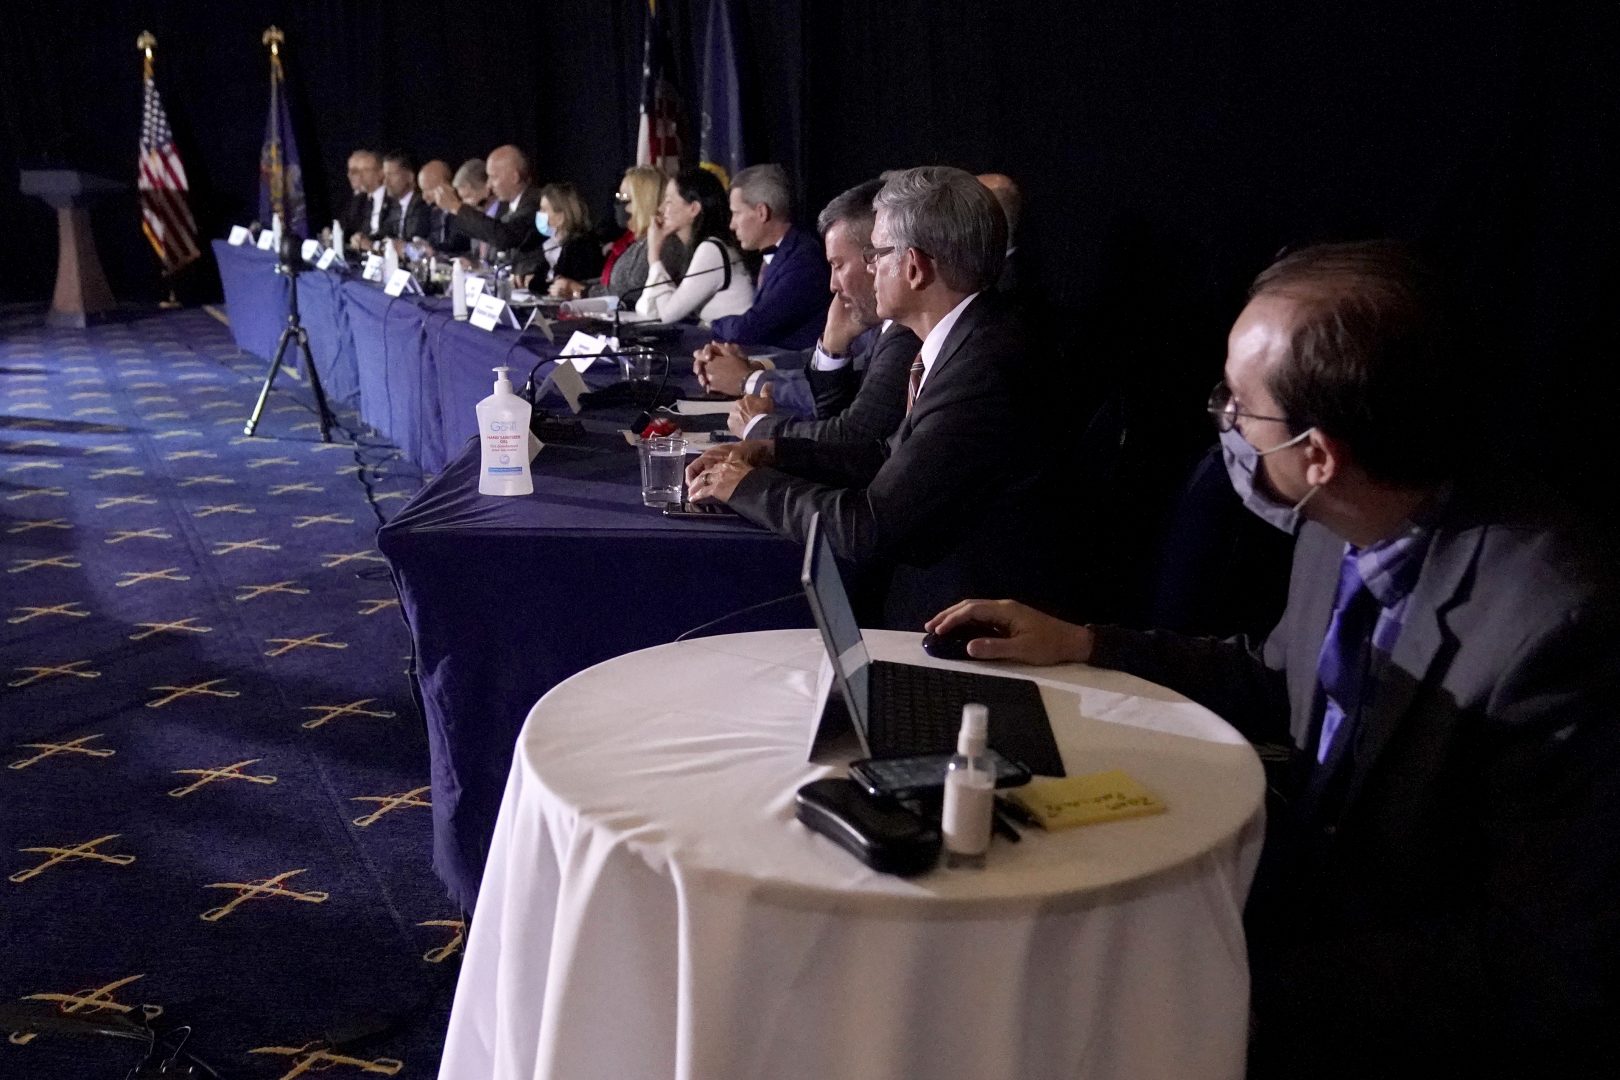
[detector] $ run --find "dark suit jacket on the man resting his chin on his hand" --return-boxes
[748,322,922,444]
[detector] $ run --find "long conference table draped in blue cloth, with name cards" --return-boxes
[214,241,808,912]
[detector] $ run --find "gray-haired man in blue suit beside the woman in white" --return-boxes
[710,165,826,348]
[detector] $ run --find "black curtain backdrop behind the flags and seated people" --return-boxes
[0,0,1620,498]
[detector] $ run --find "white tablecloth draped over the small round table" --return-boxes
[439,630,1264,1080]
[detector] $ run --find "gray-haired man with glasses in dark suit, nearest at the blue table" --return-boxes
[687,167,1053,630]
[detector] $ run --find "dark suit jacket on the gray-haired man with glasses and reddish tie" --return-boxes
[731,295,1053,630]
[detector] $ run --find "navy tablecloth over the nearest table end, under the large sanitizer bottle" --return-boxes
[377,424,808,910]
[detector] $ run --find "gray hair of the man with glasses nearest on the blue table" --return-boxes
[875,165,1008,293]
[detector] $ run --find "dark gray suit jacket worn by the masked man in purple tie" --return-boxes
[1094,476,1620,1078]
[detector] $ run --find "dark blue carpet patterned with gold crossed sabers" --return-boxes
[0,309,462,1078]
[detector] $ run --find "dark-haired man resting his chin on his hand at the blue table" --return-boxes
[693,180,922,442]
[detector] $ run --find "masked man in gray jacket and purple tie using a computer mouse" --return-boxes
[928,243,1620,1078]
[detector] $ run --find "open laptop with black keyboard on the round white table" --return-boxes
[799,515,1064,776]
